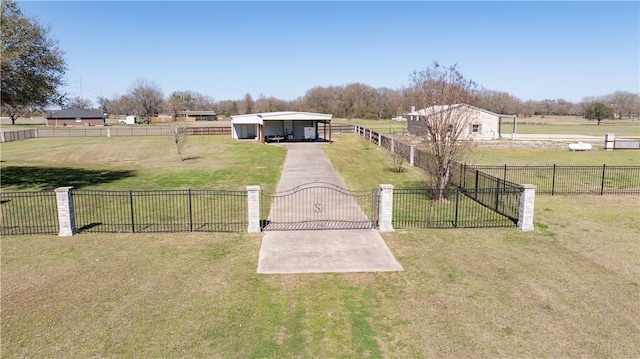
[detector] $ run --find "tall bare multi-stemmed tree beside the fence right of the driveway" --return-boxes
[407,62,476,200]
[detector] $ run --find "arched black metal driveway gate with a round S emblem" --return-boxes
[261,182,378,231]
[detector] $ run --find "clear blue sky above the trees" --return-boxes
[18,1,640,102]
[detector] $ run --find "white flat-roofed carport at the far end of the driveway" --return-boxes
[231,111,333,143]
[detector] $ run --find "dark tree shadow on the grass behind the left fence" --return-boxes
[1,166,135,190]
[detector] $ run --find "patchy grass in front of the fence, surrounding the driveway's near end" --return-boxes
[1,196,640,358]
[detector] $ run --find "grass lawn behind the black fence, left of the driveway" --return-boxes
[1,136,286,191]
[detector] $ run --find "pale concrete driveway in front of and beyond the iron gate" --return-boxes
[257,143,403,273]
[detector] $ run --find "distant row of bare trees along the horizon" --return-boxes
[92,79,640,120]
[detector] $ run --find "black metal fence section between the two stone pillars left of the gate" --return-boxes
[72,190,248,233]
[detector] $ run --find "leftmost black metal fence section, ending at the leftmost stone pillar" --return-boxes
[0,191,59,235]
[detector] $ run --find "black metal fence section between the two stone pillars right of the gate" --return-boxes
[392,188,519,228]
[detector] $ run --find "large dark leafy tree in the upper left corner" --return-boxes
[0,0,67,125]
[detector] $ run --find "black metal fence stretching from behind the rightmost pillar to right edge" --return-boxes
[473,165,640,195]
